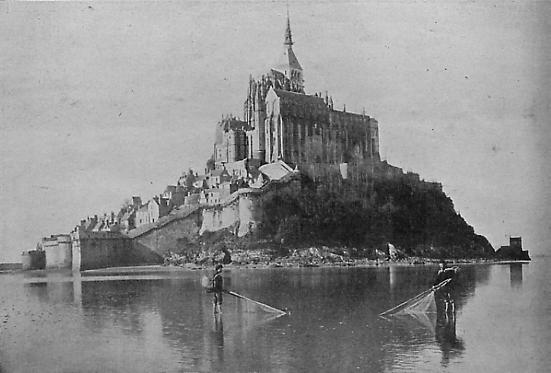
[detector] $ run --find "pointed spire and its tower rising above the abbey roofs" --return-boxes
[272,11,304,93]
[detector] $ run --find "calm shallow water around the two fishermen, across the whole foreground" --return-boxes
[0,258,551,372]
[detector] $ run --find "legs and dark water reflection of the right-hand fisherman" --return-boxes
[434,284,465,367]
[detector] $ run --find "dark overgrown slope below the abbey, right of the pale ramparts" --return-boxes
[261,165,494,258]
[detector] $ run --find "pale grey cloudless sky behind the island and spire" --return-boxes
[0,0,551,262]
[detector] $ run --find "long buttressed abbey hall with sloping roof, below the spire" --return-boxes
[265,89,379,165]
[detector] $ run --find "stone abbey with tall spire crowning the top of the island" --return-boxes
[214,14,380,180]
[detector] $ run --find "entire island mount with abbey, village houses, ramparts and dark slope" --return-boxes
[19,17,528,270]
